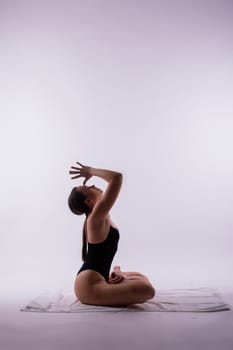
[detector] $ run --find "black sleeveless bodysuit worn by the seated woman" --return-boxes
[77,226,120,282]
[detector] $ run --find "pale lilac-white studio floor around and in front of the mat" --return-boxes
[0,290,233,350]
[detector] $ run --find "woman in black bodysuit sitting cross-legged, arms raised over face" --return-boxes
[68,162,155,306]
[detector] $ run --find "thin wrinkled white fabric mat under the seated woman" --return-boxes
[20,288,231,313]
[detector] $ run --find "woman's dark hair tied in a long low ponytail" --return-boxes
[68,187,91,261]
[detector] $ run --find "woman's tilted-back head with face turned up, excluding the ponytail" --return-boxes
[68,185,103,216]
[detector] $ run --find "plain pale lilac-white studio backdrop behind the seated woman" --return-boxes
[0,0,233,296]
